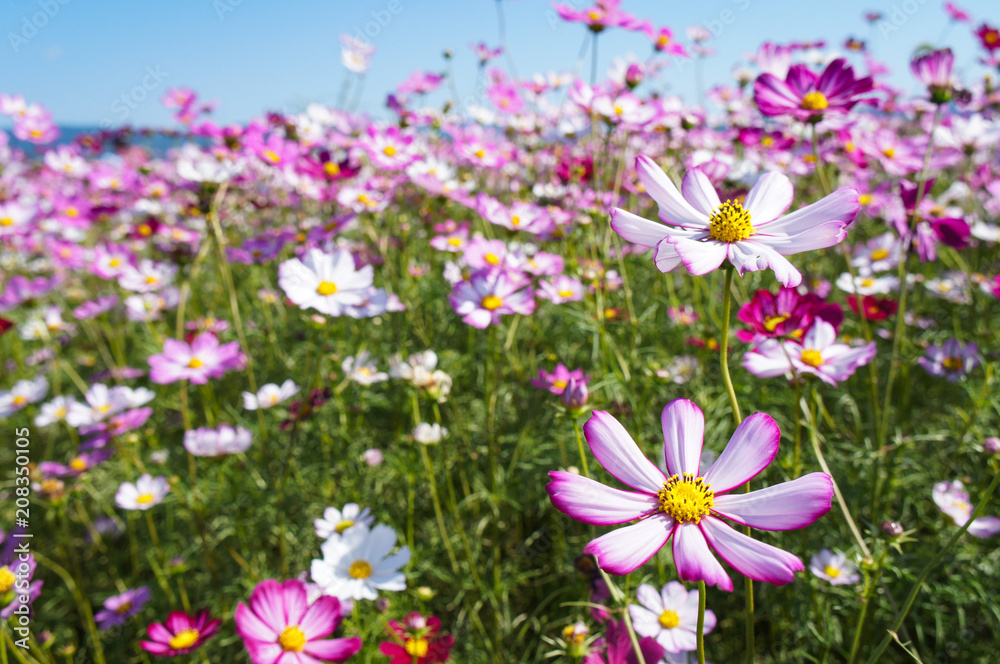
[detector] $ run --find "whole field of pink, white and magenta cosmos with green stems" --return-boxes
[0,0,1000,664]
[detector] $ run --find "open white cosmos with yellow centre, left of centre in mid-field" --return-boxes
[278,249,373,316]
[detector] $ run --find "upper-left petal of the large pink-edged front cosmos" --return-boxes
[583,410,666,493]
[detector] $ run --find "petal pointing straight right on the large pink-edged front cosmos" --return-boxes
[712,473,833,530]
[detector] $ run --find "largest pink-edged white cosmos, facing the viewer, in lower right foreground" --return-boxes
[546,399,833,591]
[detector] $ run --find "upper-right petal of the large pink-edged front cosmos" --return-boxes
[705,413,781,495]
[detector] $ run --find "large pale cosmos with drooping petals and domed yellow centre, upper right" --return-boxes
[611,160,860,287]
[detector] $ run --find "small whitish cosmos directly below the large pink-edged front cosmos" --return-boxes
[628,581,715,653]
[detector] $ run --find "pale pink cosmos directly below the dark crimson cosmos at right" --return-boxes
[743,318,875,385]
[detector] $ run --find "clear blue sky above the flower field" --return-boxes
[0,0,1000,126]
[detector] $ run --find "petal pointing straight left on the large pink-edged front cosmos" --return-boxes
[545,471,660,526]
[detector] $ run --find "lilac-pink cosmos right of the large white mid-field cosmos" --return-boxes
[449,268,535,329]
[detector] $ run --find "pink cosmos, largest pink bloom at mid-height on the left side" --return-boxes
[148,332,246,385]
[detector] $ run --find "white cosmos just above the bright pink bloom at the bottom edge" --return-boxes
[310,525,410,600]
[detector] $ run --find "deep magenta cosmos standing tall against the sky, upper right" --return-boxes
[753,58,872,122]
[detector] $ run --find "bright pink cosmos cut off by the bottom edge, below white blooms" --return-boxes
[235,579,361,664]
